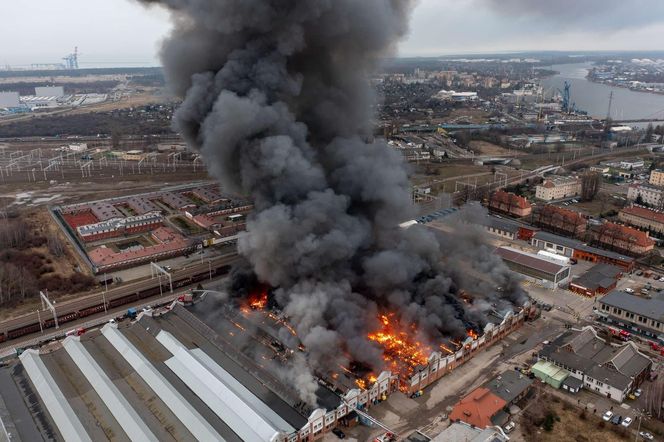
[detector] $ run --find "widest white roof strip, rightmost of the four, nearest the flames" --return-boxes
[157,330,288,441]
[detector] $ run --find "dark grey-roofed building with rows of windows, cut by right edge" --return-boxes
[594,290,664,343]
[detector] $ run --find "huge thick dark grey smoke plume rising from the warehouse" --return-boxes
[143,0,518,402]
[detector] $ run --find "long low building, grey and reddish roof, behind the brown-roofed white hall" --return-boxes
[531,232,636,272]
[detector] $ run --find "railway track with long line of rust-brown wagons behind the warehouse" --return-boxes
[0,253,239,343]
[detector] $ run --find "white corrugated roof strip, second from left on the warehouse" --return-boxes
[62,336,159,441]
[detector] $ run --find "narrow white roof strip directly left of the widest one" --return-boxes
[101,324,224,441]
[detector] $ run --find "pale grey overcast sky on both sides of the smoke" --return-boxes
[0,0,664,67]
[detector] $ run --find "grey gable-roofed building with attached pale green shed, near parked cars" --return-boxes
[533,326,652,402]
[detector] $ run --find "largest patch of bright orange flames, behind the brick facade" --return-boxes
[367,314,431,376]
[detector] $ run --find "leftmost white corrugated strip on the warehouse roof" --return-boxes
[20,350,92,442]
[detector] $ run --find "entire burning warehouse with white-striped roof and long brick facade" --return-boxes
[0,288,529,442]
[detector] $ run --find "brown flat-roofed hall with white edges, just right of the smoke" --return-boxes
[496,247,570,289]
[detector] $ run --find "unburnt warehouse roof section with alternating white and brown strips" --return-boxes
[0,298,332,442]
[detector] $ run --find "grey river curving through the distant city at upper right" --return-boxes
[542,63,664,120]
